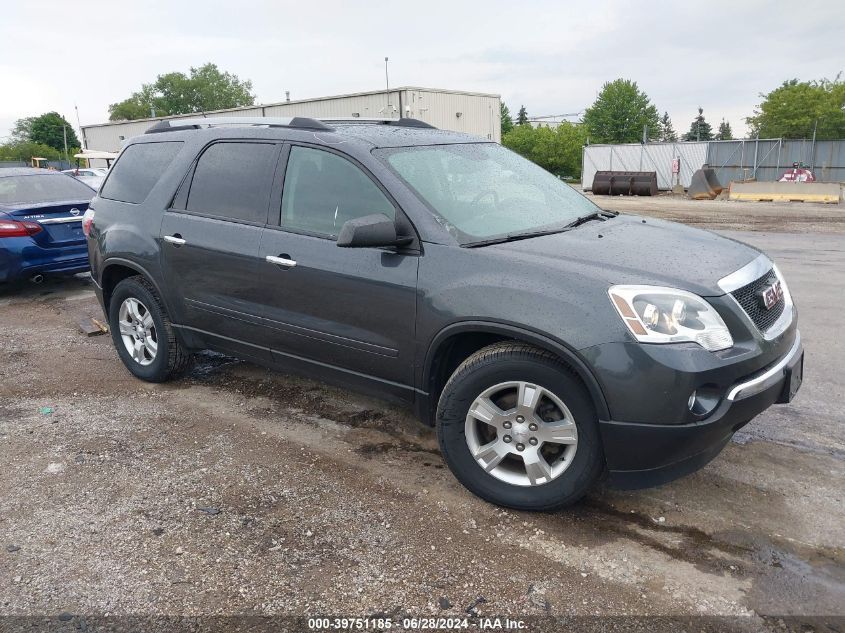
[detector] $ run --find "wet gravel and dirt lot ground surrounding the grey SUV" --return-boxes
[0,199,845,631]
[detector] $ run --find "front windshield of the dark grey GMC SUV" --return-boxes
[376,143,600,244]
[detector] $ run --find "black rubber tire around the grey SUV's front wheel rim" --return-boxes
[437,341,605,511]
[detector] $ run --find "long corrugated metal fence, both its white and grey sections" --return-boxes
[581,139,845,189]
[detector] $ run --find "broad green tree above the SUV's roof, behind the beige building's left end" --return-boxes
[109,64,255,121]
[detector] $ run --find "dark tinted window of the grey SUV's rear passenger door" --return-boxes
[188,142,276,224]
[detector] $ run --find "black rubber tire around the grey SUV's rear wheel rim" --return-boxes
[109,276,193,382]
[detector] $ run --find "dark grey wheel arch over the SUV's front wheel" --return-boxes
[418,321,610,424]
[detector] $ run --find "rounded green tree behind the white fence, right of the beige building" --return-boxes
[584,79,660,143]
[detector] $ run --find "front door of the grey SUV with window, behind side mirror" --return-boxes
[259,146,419,399]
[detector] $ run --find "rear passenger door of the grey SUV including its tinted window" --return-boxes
[161,140,280,360]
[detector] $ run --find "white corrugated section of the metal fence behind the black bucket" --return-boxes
[581,142,707,189]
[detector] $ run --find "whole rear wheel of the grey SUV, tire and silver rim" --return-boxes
[109,276,193,382]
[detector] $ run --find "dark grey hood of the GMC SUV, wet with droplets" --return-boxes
[483,215,760,296]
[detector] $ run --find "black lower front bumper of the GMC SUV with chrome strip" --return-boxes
[600,330,804,489]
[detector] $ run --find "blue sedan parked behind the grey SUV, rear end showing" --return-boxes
[0,168,96,284]
